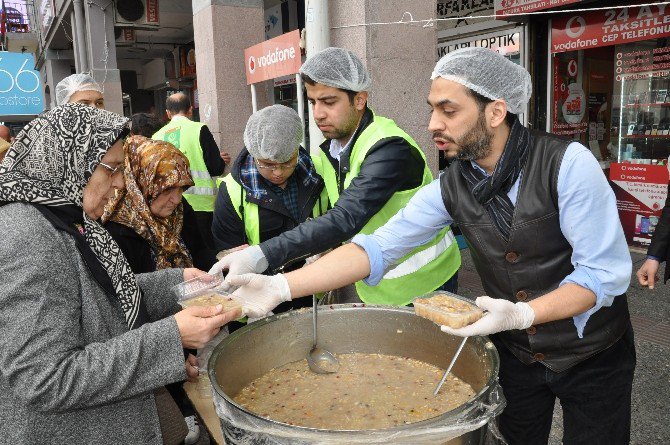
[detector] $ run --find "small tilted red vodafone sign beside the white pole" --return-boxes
[244,30,302,85]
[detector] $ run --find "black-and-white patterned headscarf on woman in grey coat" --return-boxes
[0,104,142,329]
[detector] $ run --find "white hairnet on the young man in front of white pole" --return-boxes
[300,48,372,92]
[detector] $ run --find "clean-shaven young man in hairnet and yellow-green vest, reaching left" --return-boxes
[210,48,461,306]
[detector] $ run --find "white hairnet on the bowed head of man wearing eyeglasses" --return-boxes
[244,105,302,162]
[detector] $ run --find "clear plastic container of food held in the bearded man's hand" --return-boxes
[412,291,484,329]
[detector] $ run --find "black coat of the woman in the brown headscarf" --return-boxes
[105,198,216,274]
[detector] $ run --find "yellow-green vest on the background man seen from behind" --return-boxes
[152,119,216,212]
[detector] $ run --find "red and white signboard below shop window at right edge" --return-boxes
[610,160,668,247]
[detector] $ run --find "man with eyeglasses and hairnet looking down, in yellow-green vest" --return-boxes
[212,105,328,320]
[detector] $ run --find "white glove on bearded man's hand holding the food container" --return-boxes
[440,297,535,337]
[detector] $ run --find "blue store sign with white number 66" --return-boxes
[0,51,44,116]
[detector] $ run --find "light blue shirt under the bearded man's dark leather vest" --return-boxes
[352,142,633,338]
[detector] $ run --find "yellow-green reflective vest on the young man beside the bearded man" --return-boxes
[318,112,461,306]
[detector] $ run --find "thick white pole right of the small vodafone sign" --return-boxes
[305,0,330,153]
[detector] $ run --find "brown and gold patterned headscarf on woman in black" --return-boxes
[102,136,194,269]
